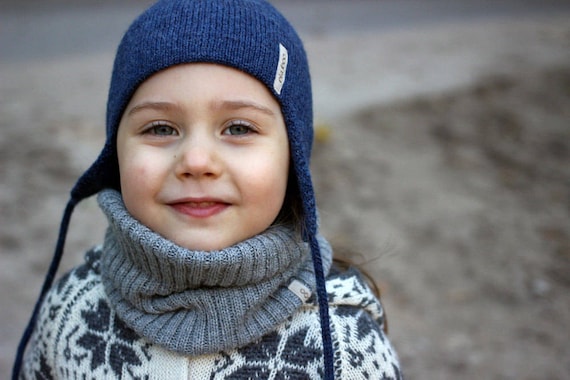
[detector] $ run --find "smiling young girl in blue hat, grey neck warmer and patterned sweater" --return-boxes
[13,0,401,379]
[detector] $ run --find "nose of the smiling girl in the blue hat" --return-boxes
[176,135,222,179]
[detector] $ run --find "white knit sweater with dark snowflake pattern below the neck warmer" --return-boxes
[21,249,402,380]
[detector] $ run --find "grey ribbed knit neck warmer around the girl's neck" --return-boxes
[98,190,332,355]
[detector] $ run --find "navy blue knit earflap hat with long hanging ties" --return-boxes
[13,0,333,379]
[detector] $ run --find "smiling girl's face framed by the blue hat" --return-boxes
[117,63,289,251]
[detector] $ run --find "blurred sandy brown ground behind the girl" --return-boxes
[0,6,570,379]
